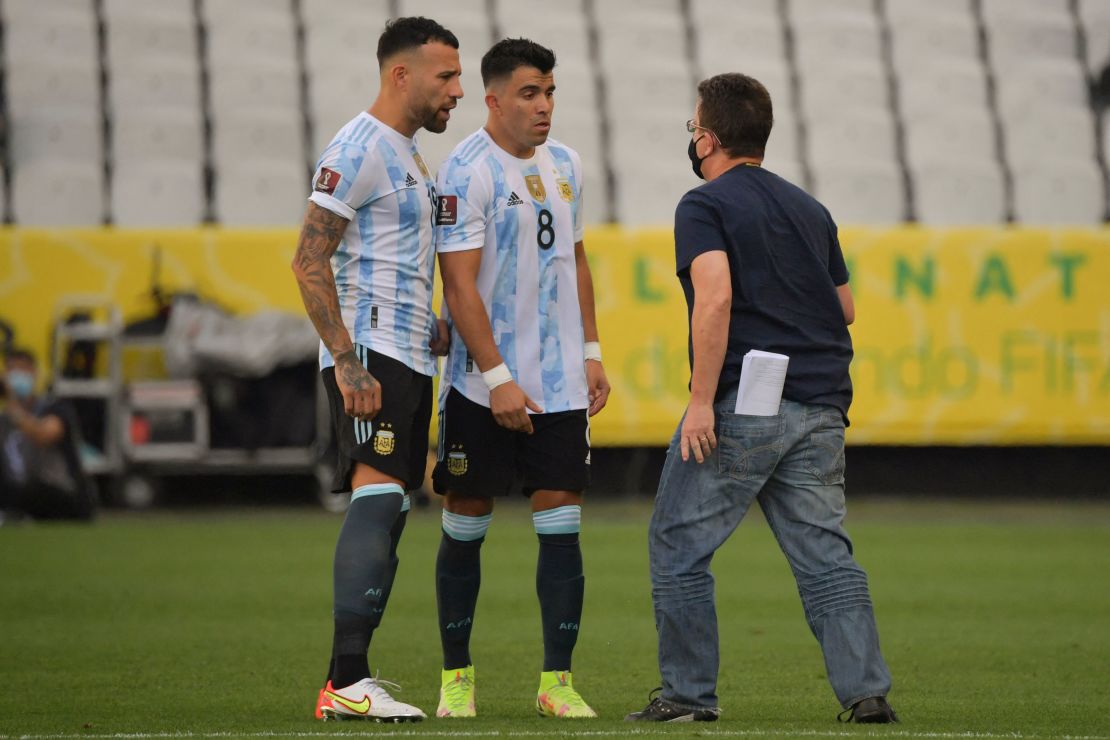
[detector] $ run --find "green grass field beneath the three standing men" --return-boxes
[0,500,1110,738]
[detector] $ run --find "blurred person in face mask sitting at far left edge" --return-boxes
[0,349,95,519]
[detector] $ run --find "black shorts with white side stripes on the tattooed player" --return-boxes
[321,344,432,494]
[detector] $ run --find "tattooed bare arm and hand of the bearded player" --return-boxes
[293,203,382,419]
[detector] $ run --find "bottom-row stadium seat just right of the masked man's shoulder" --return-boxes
[813,160,906,225]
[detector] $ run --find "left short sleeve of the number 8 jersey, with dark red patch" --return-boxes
[435,159,491,252]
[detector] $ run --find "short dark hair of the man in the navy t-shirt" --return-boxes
[697,72,775,158]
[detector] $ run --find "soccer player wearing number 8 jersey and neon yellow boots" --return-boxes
[433,39,609,718]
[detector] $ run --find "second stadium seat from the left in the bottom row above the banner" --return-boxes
[112,159,204,227]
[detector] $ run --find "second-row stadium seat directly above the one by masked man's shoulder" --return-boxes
[807,109,895,166]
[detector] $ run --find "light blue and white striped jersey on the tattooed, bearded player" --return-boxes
[309,111,436,375]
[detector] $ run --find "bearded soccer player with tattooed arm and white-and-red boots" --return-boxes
[293,18,463,721]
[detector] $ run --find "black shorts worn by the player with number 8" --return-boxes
[432,388,589,496]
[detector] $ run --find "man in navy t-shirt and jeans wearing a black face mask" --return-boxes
[627,74,897,722]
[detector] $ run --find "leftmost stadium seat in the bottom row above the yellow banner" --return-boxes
[11,160,104,226]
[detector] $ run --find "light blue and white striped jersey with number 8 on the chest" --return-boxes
[436,129,589,413]
